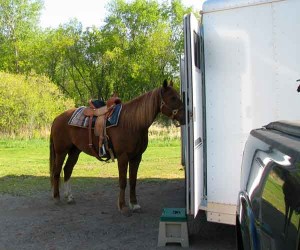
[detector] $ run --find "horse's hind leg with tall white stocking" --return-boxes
[64,146,81,204]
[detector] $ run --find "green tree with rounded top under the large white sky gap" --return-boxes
[43,20,110,105]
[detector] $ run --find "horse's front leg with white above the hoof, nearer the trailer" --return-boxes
[129,155,142,212]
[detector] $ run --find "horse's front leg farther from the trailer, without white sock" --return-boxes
[118,154,131,216]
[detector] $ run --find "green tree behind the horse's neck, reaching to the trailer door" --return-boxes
[103,0,191,100]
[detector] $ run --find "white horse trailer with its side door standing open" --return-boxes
[181,0,300,224]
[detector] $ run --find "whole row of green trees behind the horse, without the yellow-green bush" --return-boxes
[0,0,192,105]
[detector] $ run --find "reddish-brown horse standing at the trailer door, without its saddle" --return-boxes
[50,80,185,214]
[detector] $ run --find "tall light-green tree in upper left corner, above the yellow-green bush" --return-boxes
[0,0,43,73]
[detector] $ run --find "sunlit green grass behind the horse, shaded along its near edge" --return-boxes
[0,133,184,196]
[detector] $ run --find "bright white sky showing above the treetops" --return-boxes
[41,0,203,28]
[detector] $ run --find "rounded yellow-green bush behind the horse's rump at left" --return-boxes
[0,72,74,138]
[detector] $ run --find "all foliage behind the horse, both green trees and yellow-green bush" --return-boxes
[0,0,197,136]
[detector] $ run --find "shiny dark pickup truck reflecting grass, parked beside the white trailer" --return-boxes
[236,121,300,250]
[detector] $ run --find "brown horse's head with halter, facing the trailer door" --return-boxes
[160,80,185,125]
